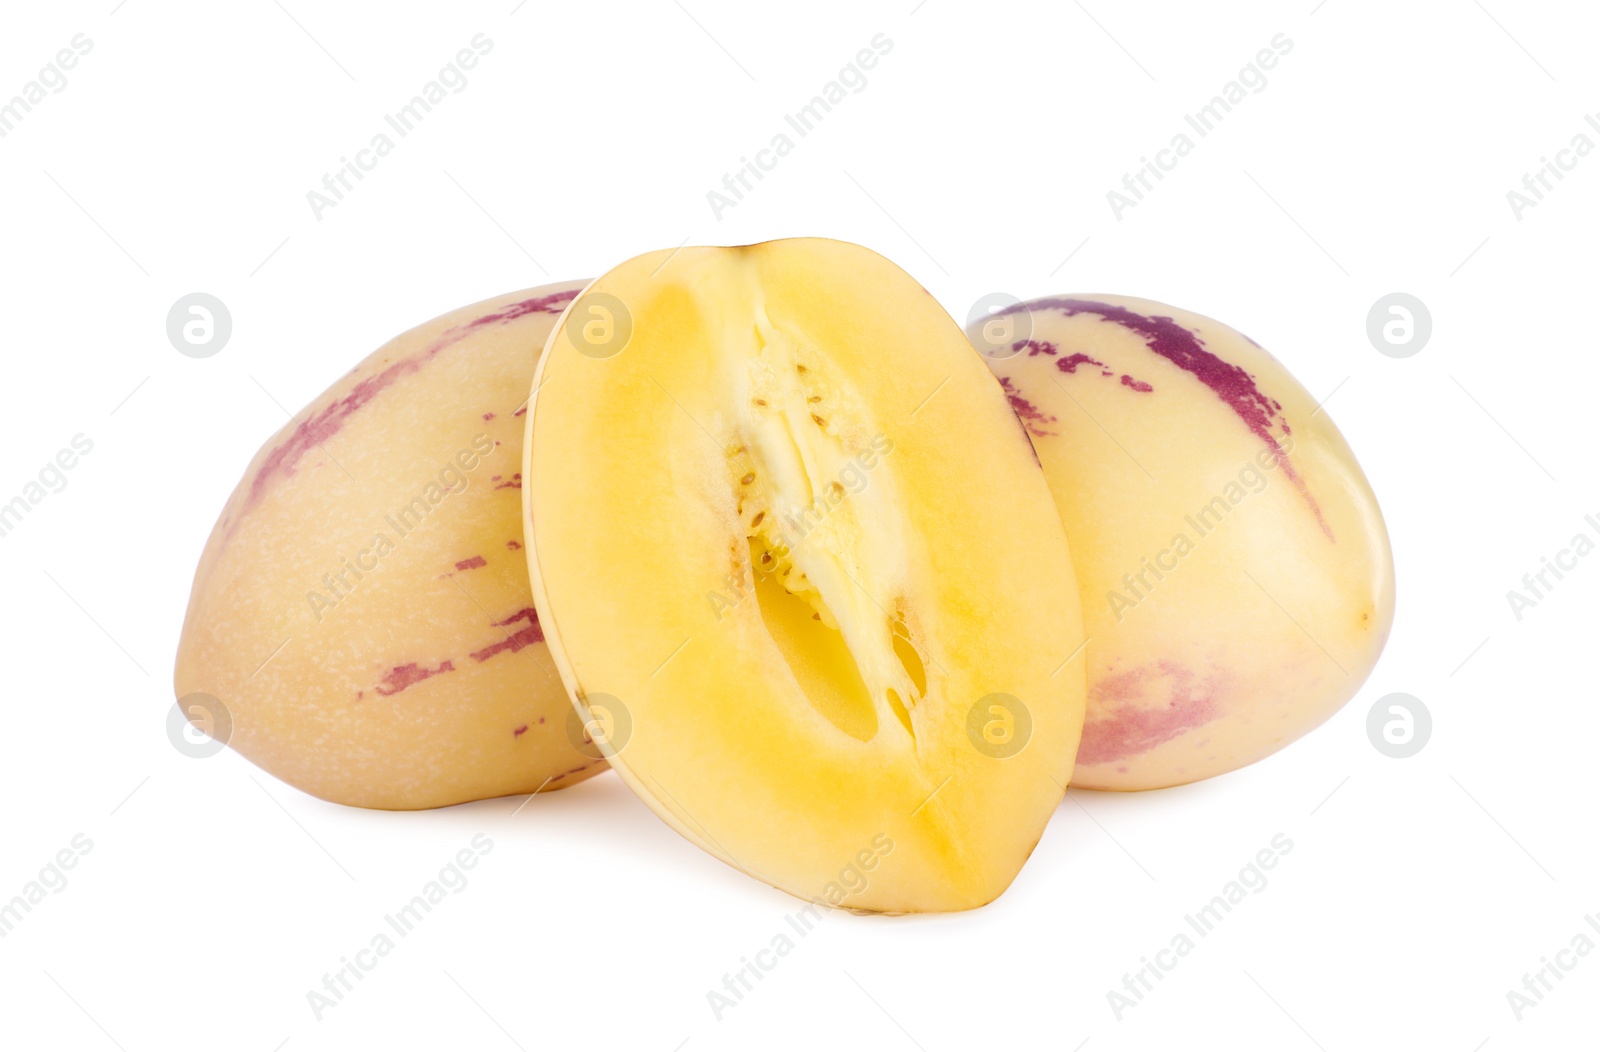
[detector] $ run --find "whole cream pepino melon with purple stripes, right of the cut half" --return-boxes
[970,294,1394,790]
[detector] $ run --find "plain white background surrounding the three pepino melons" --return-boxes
[0,0,1600,1052]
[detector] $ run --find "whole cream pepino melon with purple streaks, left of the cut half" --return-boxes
[174,281,605,809]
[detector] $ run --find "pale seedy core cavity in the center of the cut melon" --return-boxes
[728,301,928,745]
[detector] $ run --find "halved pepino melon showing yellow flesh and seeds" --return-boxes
[523,238,1083,911]
